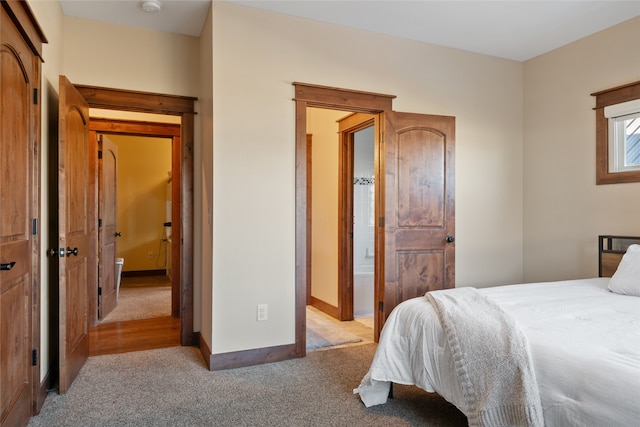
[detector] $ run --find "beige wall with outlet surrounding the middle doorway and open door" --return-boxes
[212,2,523,353]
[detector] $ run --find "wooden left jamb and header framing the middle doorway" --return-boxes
[293,82,395,357]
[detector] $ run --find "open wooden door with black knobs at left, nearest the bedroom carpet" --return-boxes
[58,76,98,393]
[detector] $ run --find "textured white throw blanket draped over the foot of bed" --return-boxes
[425,287,544,427]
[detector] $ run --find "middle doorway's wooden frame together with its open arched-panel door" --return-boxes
[293,82,455,357]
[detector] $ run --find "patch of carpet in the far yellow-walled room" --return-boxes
[102,286,171,323]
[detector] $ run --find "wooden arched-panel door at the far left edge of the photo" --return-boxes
[0,2,40,426]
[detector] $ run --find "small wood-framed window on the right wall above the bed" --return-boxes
[592,82,640,184]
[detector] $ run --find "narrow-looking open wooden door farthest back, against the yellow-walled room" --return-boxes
[97,132,118,319]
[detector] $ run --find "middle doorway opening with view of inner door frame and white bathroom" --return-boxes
[306,108,375,349]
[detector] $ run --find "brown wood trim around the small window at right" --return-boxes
[591,81,640,185]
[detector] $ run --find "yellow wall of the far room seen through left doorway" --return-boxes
[106,135,171,271]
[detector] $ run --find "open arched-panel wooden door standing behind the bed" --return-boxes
[376,111,455,339]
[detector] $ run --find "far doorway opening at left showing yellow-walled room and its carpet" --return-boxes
[98,133,172,323]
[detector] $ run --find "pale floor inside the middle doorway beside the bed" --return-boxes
[307,306,373,350]
